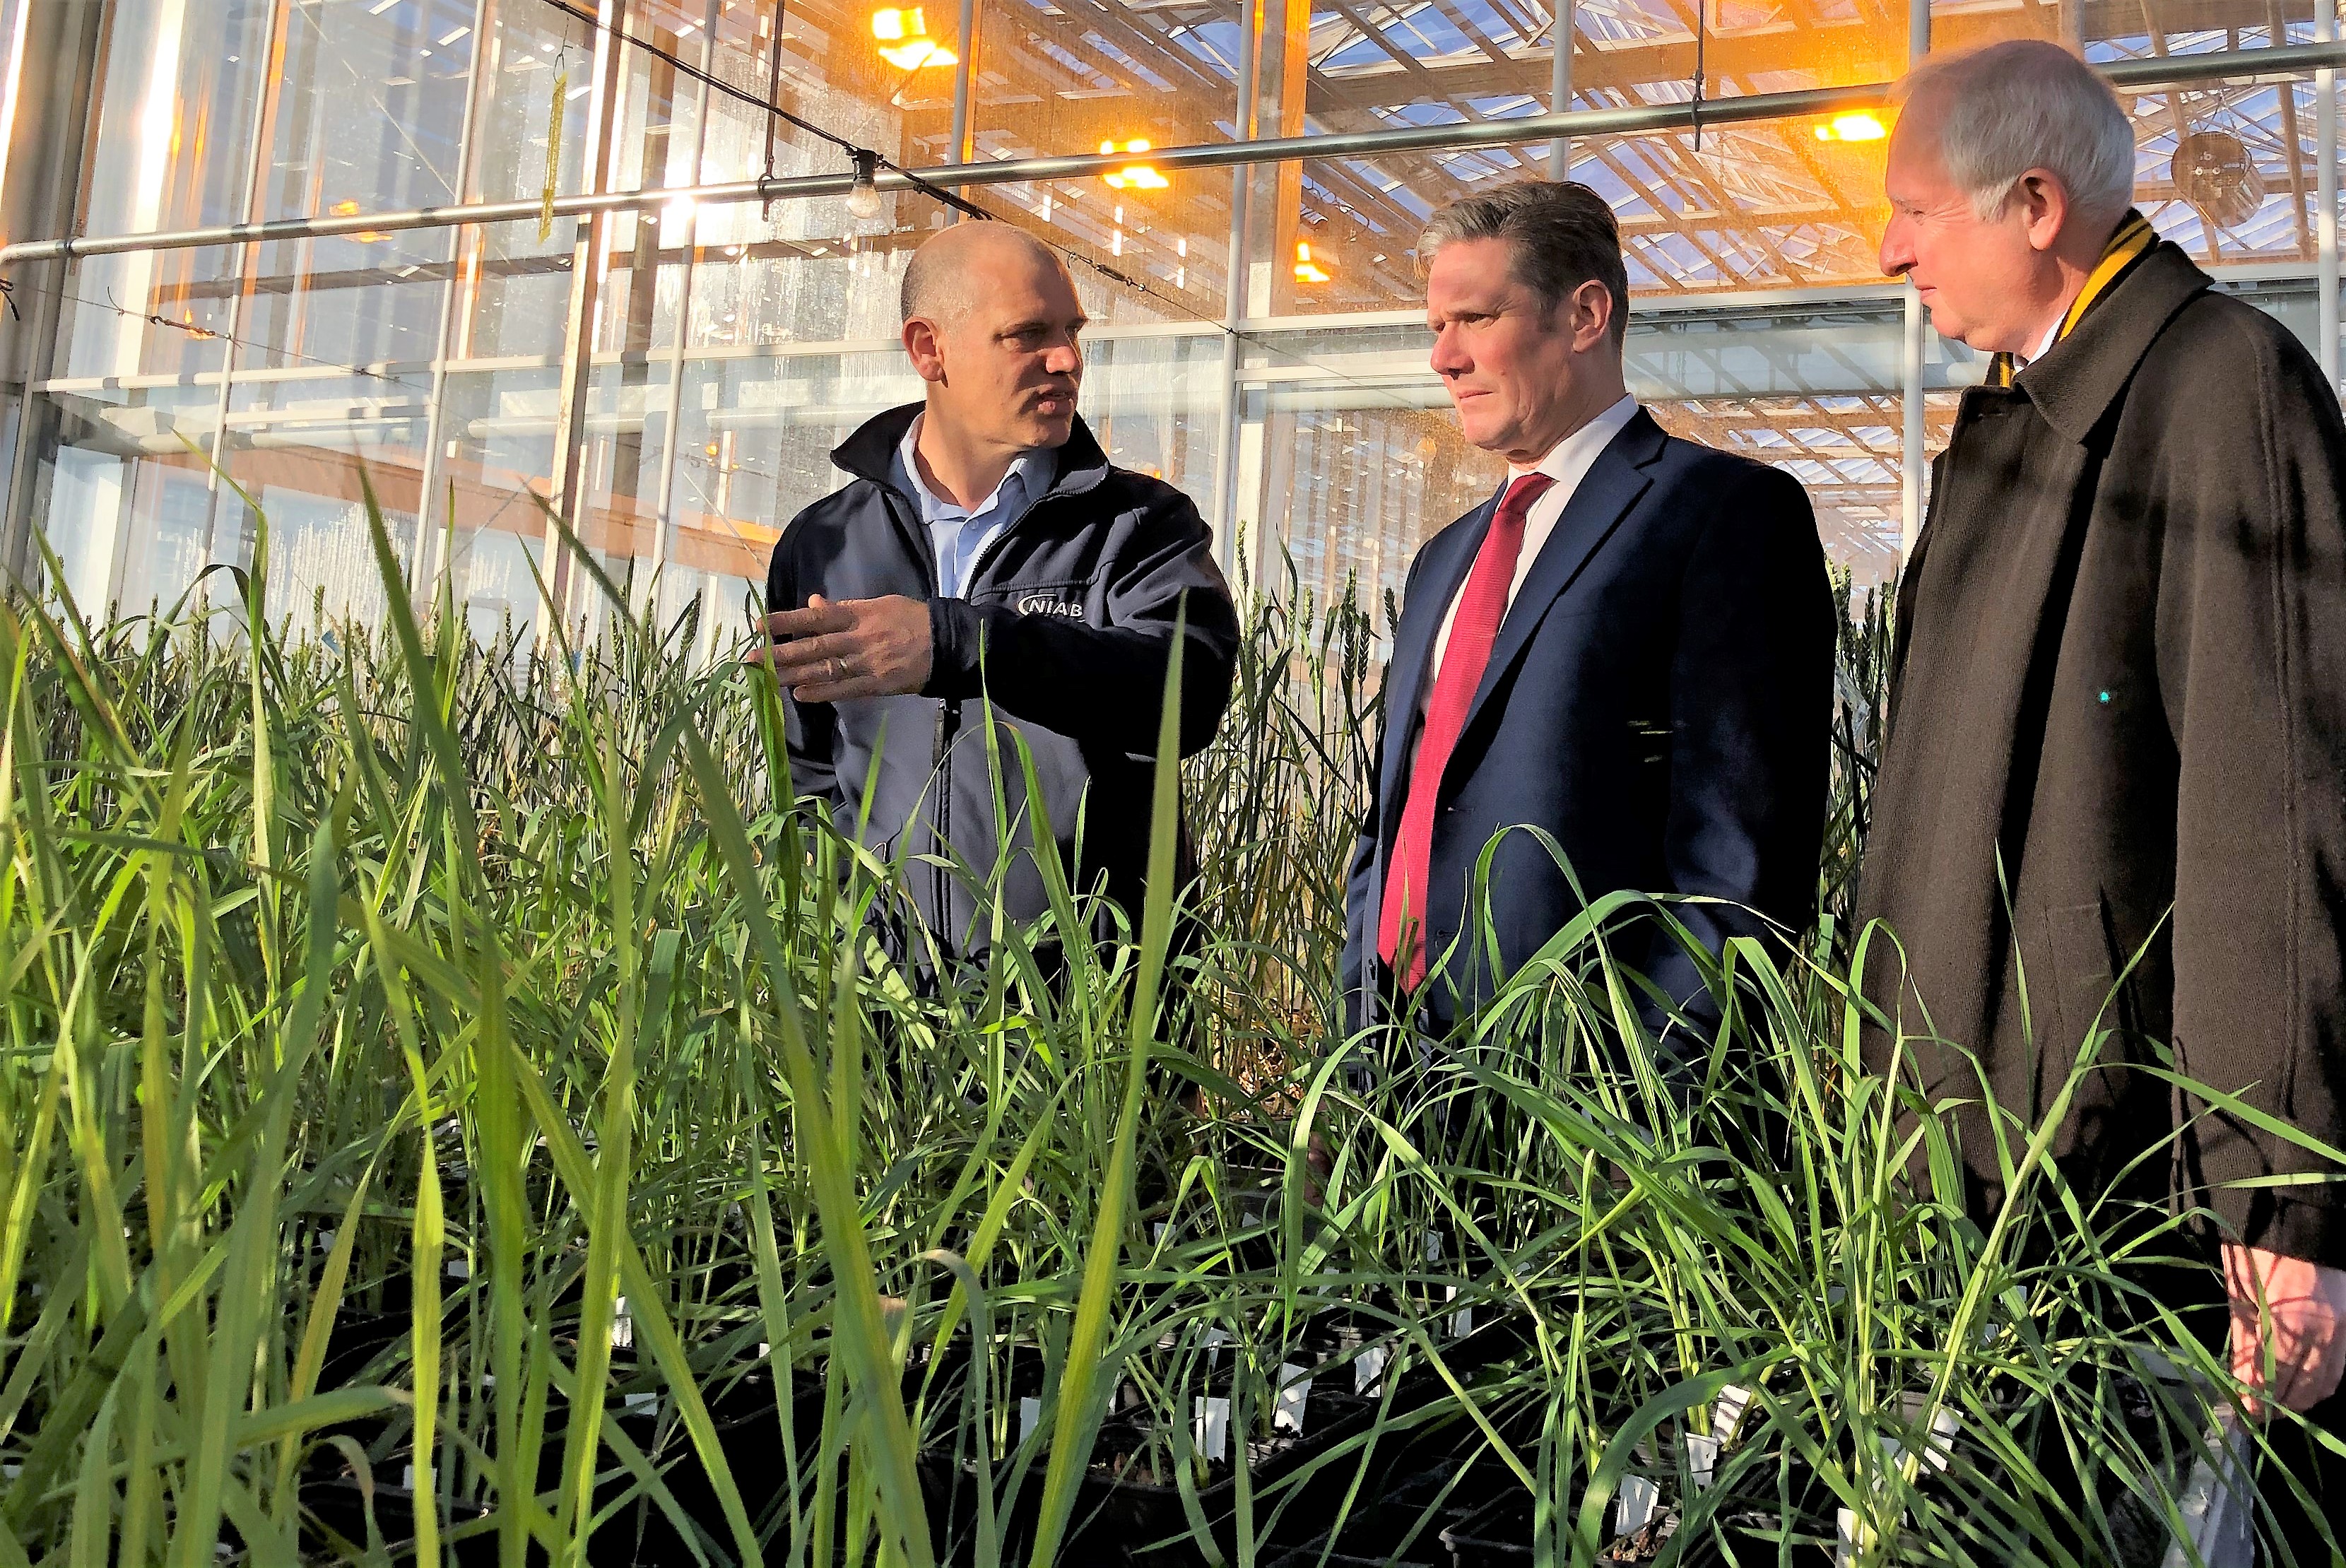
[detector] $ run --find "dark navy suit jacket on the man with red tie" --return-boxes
[1342,408,1834,1026]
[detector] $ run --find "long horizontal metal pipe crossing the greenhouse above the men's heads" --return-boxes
[0,42,2346,268]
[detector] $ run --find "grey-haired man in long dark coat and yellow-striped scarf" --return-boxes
[1861,42,2346,1492]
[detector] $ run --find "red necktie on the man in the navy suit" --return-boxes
[1377,474,1555,989]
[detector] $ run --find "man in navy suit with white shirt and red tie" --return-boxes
[1342,181,1834,1028]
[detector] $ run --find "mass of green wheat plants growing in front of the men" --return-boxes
[0,490,2327,1568]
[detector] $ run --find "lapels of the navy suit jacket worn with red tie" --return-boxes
[1381,408,1670,840]
